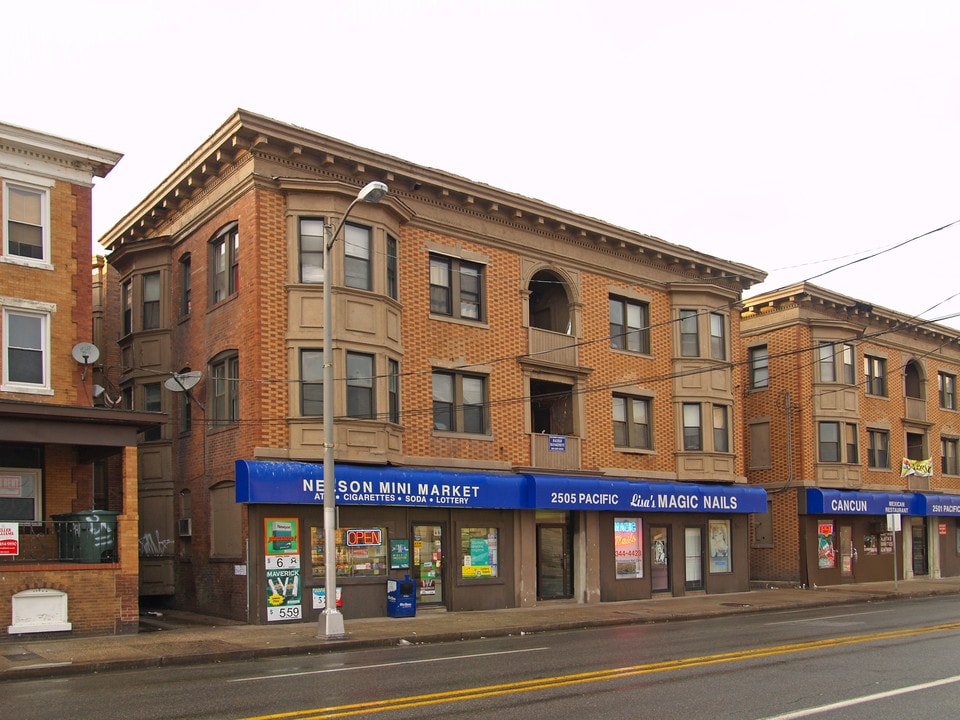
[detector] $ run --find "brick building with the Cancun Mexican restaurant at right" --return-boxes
[739,283,960,585]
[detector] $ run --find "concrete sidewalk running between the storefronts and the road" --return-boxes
[0,577,960,681]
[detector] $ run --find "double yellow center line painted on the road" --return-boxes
[238,622,960,720]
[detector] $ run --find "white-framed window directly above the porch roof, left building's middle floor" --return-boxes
[3,308,50,392]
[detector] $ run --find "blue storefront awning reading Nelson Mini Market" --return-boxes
[236,460,531,509]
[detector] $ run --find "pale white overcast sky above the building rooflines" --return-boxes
[7,0,960,327]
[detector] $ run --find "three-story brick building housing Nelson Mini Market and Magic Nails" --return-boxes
[101,110,765,622]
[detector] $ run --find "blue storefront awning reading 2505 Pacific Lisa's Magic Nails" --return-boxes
[529,475,767,513]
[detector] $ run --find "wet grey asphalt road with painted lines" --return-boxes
[7,596,960,720]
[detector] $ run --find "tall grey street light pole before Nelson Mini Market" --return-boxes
[317,181,387,640]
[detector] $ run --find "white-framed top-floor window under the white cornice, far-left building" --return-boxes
[3,182,50,264]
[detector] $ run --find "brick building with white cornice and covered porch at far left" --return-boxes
[0,124,157,635]
